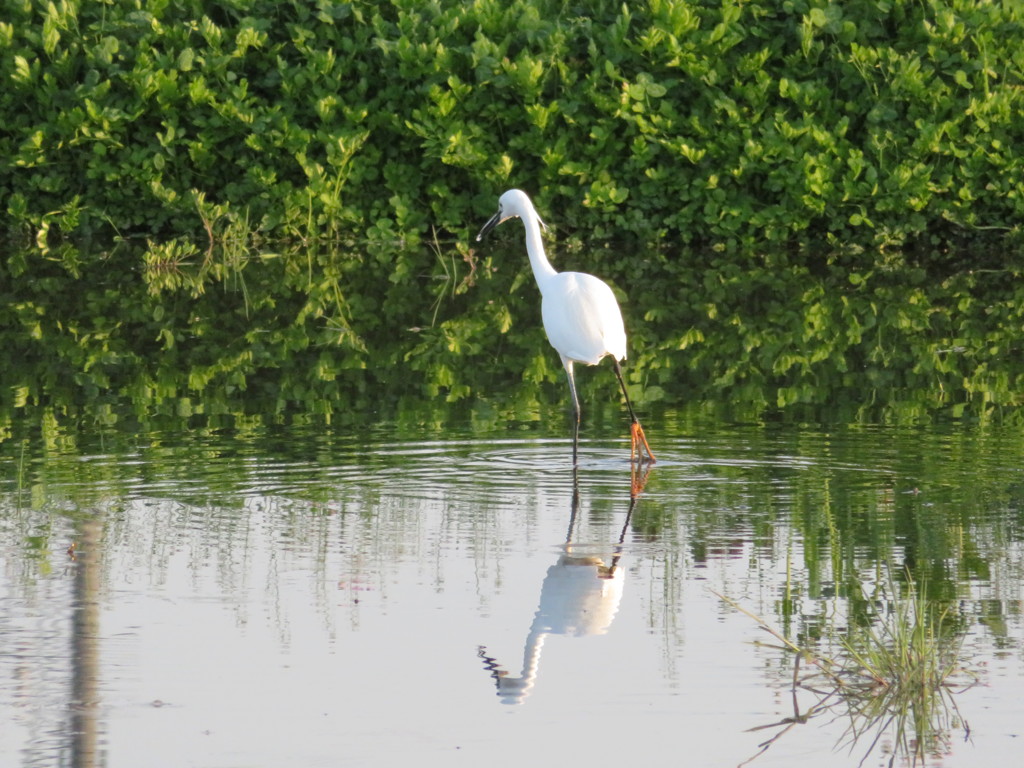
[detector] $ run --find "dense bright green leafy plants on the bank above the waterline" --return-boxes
[0,0,1024,248]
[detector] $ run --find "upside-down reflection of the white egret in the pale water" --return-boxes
[477,472,638,705]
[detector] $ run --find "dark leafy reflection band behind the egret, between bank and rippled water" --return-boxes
[6,243,1024,421]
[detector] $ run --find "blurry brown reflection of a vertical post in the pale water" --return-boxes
[71,513,102,768]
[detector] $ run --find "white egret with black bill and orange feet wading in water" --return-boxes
[476,189,654,466]
